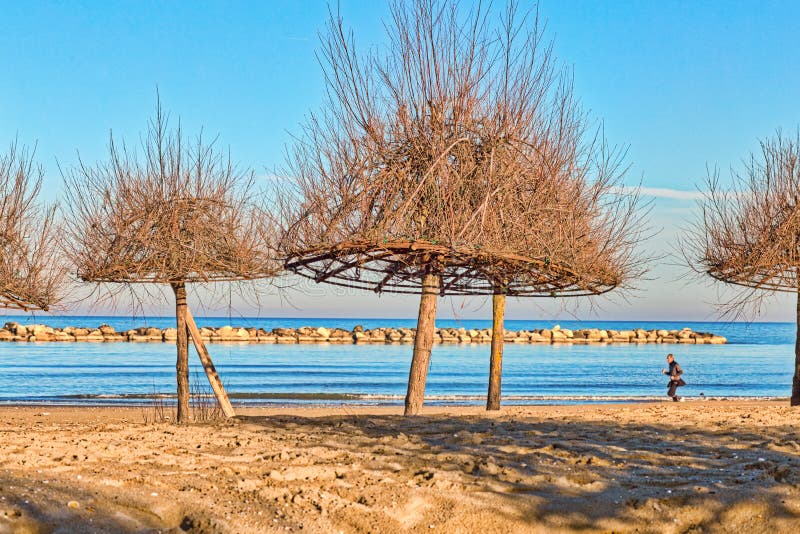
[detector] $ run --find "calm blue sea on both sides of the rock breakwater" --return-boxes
[0,316,795,404]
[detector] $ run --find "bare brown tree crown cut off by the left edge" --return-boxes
[0,143,66,312]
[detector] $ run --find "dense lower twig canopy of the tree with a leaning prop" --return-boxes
[71,196,280,284]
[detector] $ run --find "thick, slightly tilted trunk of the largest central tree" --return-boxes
[405,272,441,415]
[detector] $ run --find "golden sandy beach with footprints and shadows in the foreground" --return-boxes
[0,400,800,533]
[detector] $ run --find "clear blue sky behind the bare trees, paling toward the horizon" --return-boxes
[0,0,800,320]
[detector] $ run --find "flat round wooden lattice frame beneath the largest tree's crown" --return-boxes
[284,240,621,297]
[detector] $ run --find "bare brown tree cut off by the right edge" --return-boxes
[685,132,800,406]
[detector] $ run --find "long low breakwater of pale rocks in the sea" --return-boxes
[0,323,727,345]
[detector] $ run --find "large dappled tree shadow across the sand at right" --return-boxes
[239,415,800,531]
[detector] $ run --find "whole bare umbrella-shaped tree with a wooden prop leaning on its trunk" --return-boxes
[65,104,276,422]
